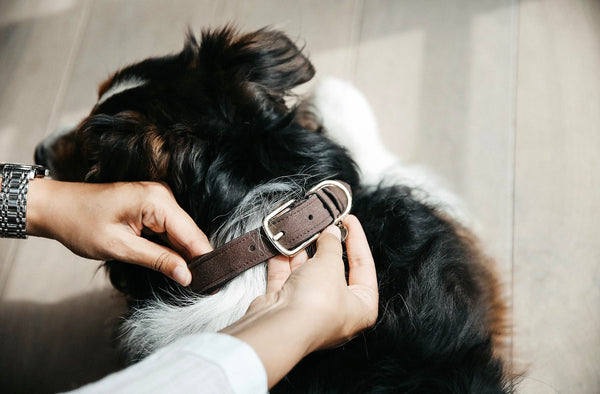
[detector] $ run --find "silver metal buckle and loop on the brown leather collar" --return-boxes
[262,180,352,257]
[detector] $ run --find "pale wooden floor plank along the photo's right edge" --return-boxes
[514,0,600,393]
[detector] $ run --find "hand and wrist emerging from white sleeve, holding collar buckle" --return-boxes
[222,215,379,387]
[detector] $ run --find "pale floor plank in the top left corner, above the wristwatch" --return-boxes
[0,0,82,163]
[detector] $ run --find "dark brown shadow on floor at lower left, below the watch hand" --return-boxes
[0,289,127,393]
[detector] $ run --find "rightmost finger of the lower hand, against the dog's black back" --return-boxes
[344,215,377,290]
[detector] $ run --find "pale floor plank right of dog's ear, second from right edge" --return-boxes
[355,0,518,312]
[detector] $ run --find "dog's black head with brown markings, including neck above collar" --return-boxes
[36,28,358,297]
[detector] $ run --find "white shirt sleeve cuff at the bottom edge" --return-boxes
[66,333,268,394]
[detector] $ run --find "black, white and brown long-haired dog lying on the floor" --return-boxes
[35,26,514,393]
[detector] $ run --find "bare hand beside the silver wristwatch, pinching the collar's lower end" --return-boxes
[26,179,212,286]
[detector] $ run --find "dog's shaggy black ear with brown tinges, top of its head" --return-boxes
[195,27,315,116]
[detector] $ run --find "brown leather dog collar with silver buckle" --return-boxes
[188,180,352,293]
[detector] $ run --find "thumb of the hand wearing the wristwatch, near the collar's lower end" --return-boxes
[119,236,192,286]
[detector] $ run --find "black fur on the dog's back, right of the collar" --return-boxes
[272,186,510,393]
